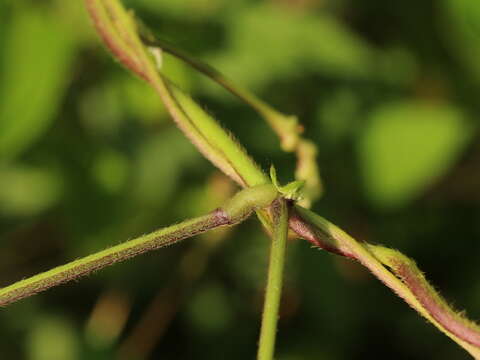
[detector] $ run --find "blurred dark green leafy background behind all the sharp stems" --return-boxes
[0,0,480,360]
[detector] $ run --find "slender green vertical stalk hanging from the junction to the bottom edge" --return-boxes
[257,199,288,360]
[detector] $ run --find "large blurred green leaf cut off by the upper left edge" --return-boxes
[0,5,74,160]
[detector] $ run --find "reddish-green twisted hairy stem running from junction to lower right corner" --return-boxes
[290,206,480,359]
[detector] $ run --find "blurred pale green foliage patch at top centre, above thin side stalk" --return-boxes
[204,4,375,90]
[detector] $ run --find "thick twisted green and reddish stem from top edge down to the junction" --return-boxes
[84,0,268,187]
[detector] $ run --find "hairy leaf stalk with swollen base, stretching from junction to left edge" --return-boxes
[0,185,277,306]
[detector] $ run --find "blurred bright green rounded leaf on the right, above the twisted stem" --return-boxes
[358,102,470,208]
